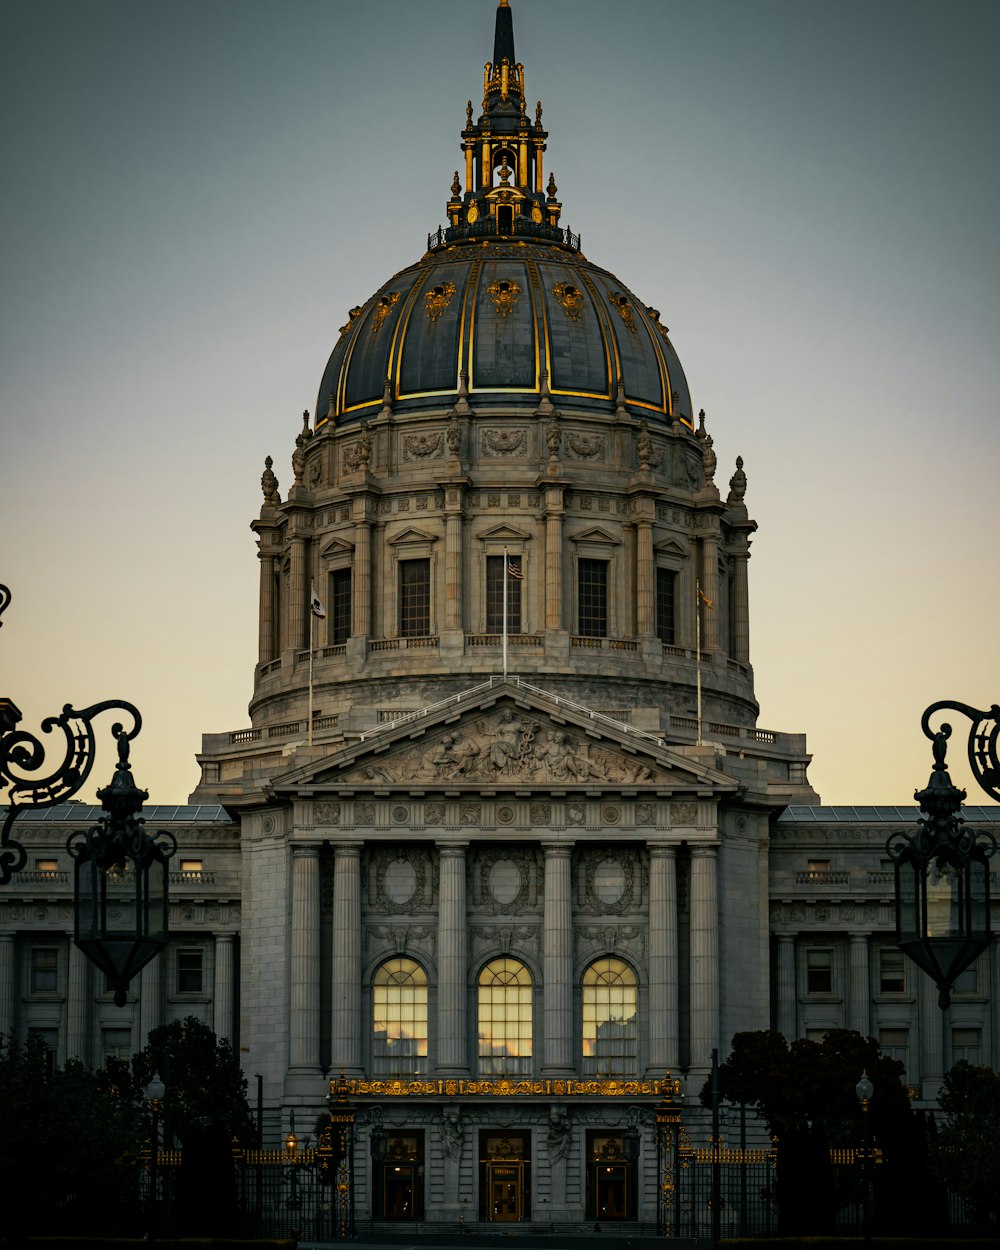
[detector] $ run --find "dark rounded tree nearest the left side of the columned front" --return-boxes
[133,1016,256,1235]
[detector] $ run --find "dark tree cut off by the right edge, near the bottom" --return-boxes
[935,1059,1000,1230]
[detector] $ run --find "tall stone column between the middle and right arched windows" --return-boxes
[541,844,574,1078]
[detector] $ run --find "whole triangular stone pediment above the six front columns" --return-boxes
[271,690,736,794]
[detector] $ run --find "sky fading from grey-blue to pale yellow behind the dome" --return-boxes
[0,0,1000,804]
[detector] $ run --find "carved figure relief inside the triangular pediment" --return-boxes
[343,708,655,785]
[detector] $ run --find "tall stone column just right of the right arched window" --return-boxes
[649,843,680,1076]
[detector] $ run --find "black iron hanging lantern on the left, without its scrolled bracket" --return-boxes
[66,725,178,1008]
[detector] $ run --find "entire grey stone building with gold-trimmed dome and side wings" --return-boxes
[0,0,1000,1226]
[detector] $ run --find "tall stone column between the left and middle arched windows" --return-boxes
[438,843,469,1075]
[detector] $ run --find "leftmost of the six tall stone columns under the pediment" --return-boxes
[289,846,320,1071]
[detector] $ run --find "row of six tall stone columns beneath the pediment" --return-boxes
[289,840,720,1079]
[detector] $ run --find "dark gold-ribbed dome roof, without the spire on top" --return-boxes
[316,236,691,426]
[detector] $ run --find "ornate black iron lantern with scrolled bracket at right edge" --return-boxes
[885,703,1000,1009]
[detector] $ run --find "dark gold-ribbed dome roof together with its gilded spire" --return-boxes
[315,0,693,430]
